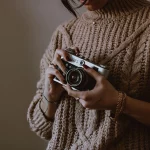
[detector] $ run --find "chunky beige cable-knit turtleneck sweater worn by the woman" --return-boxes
[27,0,150,150]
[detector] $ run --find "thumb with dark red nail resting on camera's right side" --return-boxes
[83,65,102,81]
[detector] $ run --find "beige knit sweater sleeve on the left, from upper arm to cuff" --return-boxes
[27,27,62,140]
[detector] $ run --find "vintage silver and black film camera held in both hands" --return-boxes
[54,48,109,91]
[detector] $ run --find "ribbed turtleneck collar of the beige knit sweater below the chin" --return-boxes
[82,0,150,23]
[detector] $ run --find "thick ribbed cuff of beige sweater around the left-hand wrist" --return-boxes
[28,101,53,140]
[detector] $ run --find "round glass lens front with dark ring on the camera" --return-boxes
[66,68,84,87]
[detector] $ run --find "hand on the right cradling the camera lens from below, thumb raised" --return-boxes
[63,66,118,110]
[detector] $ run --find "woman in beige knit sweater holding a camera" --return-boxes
[28,0,150,150]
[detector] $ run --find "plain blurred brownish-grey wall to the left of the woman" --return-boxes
[0,0,83,150]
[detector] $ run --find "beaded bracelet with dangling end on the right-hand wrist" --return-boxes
[115,91,127,138]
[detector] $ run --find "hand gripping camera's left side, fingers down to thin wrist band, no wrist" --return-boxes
[44,49,70,101]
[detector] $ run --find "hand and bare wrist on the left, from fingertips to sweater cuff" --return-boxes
[41,49,77,119]
